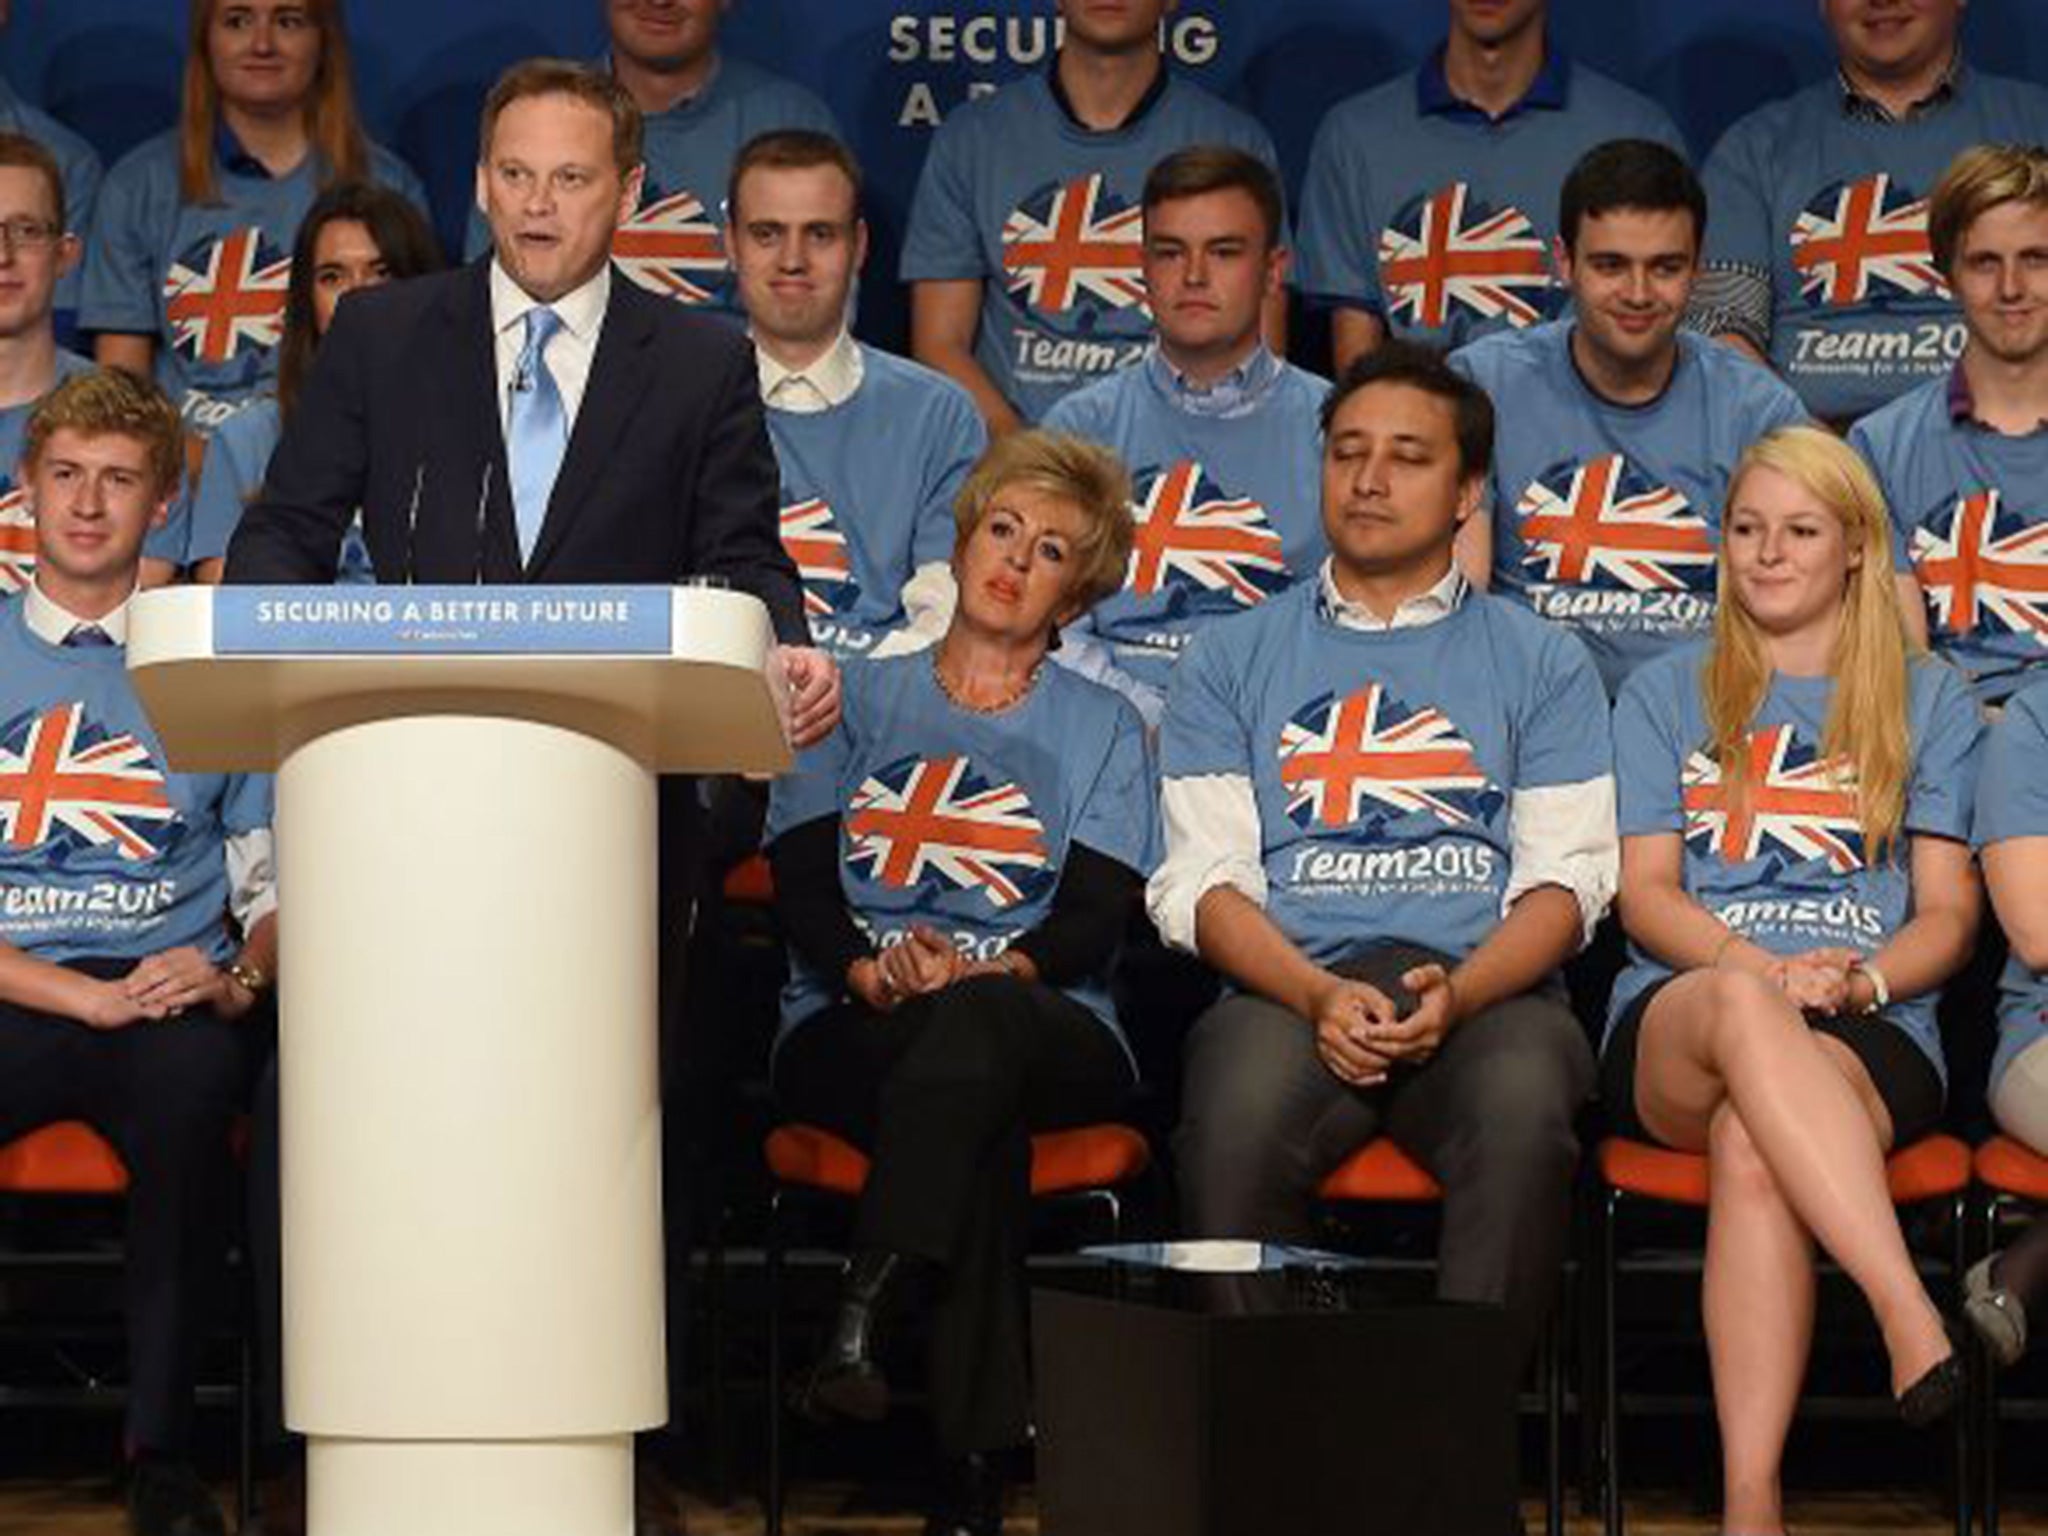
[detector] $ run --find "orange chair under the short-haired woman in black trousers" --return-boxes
[764,1124,1151,1536]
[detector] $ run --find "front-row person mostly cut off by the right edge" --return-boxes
[1966,682,2048,1366]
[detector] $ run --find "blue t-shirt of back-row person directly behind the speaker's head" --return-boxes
[463,53,842,315]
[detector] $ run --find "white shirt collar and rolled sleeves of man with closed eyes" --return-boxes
[1145,559,1622,954]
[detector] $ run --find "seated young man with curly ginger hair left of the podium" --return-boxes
[0,371,276,1536]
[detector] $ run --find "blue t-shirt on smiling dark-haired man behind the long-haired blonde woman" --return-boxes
[1452,319,1806,694]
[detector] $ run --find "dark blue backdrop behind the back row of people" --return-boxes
[0,0,2048,342]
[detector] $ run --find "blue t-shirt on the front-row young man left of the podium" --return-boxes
[0,602,270,963]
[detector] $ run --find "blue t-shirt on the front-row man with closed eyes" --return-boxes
[1159,580,1610,965]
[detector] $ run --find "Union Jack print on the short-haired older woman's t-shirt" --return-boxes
[846,756,1053,909]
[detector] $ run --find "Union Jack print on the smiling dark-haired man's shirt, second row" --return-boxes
[1516,453,1714,592]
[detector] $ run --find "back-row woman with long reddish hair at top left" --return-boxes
[78,0,426,561]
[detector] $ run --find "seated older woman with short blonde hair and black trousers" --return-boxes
[768,432,1155,1536]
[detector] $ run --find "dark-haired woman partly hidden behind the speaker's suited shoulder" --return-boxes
[184,182,440,582]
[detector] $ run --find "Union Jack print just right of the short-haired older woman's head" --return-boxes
[1124,459,1286,608]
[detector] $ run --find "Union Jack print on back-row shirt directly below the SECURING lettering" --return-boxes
[1004,172,1145,315]
